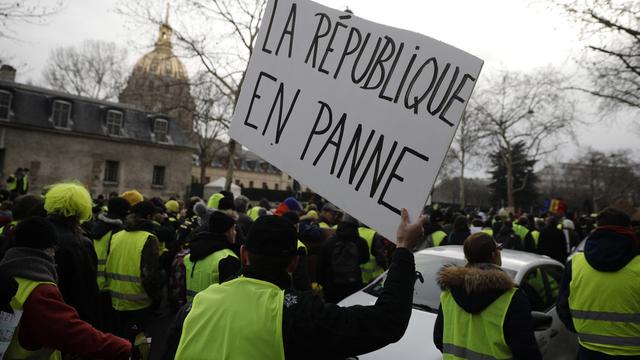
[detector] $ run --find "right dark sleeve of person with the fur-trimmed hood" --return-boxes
[503,290,542,360]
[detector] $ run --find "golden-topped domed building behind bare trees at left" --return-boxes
[119,20,195,137]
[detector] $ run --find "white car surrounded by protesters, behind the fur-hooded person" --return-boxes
[340,246,578,360]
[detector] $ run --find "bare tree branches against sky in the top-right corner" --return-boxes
[548,0,640,111]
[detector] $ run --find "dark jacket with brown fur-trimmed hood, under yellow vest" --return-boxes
[433,264,542,359]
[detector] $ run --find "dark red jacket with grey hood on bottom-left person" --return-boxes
[0,247,131,359]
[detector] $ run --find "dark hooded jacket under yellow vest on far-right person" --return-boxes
[556,227,640,360]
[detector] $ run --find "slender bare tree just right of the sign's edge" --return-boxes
[447,106,484,208]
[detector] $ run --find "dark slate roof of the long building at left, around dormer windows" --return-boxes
[0,80,193,148]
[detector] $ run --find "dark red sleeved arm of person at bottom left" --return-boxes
[18,284,131,359]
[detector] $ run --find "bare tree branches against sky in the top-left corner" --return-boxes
[0,0,64,38]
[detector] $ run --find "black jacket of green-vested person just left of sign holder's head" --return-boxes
[190,231,240,283]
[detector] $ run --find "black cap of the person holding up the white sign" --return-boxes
[245,215,298,257]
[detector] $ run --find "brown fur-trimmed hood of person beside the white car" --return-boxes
[438,263,516,314]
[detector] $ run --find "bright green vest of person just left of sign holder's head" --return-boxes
[183,249,238,302]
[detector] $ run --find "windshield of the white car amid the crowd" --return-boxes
[364,254,516,313]
